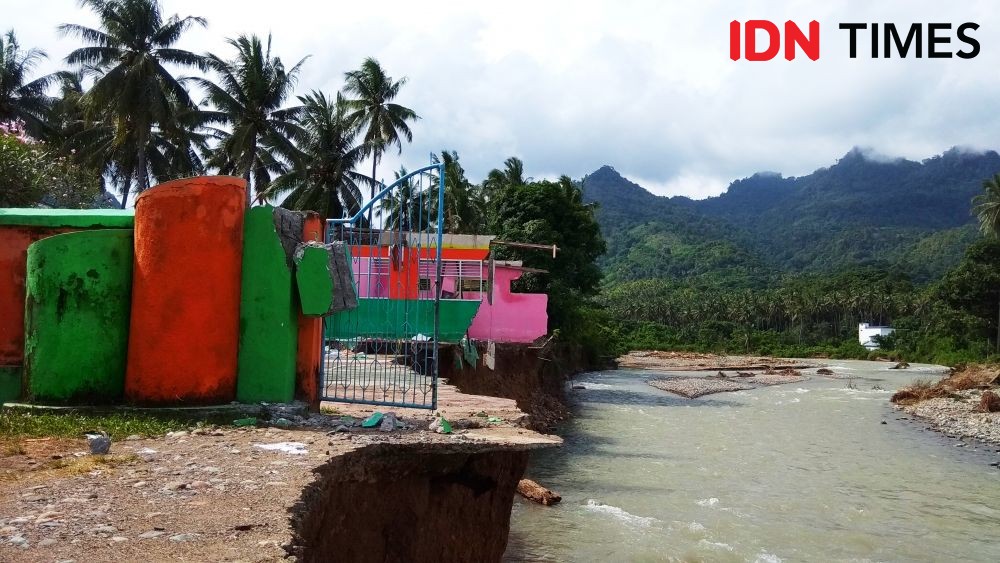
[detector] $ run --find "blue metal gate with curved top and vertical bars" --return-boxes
[320,163,444,409]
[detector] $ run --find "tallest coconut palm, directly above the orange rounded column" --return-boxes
[59,0,207,209]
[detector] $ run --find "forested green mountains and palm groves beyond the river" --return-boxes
[584,155,1000,365]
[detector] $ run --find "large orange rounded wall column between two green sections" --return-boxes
[125,176,246,404]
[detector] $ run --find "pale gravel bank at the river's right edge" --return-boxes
[896,389,1000,446]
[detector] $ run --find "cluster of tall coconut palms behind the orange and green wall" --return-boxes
[0,0,418,216]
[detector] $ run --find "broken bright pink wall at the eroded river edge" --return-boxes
[469,264,549,342]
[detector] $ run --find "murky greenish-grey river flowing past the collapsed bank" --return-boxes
[505,360,1000,562]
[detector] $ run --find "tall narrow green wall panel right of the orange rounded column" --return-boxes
[236,205,298,403]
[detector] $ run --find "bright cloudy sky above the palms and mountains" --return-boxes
[0,0,1000,198]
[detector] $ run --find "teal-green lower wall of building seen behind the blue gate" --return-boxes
[326,298,480,342]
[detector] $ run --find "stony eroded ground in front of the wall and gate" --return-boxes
[0,386,561,562]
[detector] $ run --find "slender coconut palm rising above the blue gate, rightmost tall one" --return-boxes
[344,57,420,214]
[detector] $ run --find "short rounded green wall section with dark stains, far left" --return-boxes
[24,229,132,404]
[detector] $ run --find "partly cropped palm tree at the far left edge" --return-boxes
[0,29,55,137]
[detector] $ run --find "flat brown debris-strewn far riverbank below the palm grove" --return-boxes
[617,350,822,371]
